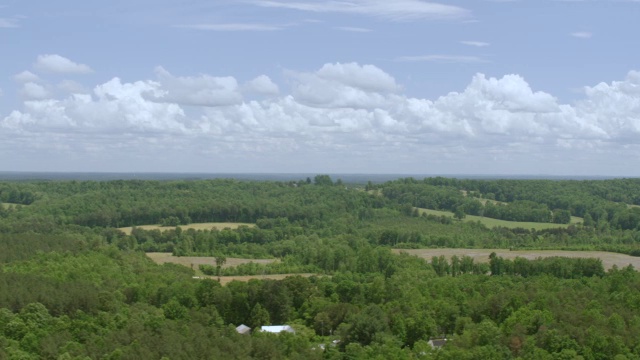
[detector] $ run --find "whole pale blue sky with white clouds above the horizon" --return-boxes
[0,0,640,177]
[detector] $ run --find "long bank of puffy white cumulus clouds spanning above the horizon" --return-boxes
[0,63,640,172]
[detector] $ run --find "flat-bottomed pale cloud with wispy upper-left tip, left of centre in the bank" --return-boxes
[148,66,242,106]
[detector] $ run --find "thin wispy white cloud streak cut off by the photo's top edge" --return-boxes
[253,0,470,21]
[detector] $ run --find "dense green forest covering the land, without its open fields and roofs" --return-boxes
[0,175,640,360]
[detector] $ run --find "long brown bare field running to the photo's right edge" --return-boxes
[393,249,640,269]
